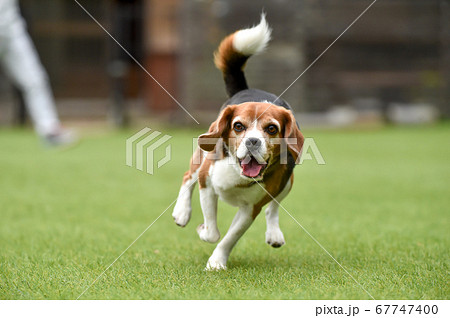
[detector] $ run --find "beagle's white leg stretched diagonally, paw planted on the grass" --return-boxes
[206,206,253,270]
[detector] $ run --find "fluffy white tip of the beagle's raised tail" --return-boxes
[233,13,272,56]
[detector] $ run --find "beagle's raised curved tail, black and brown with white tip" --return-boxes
[214,13,272,97]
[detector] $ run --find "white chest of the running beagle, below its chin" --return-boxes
[209,158,266,206]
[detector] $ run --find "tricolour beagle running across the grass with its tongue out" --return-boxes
[172,14,304,270]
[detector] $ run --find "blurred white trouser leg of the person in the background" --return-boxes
[0,7,60,135]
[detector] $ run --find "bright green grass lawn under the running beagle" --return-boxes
[0,123,450,299]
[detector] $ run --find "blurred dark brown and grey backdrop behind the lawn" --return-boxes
[0,0,450,127]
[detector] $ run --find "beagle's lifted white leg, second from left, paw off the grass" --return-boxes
[197,186,220,243]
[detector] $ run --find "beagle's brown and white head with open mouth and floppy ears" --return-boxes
[199,102,304,179]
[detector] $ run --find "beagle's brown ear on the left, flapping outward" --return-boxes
[198,106,234,151]
